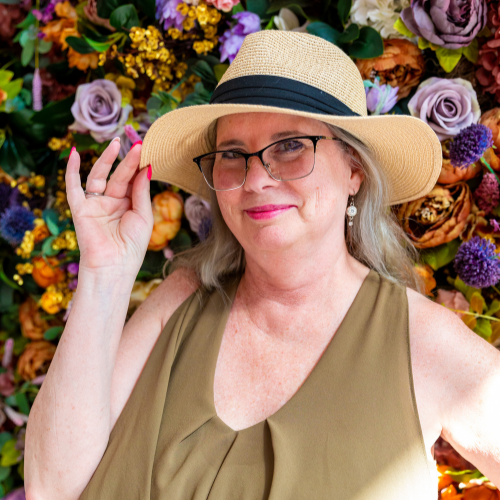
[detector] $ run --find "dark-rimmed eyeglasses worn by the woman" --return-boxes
[193,135,340,191]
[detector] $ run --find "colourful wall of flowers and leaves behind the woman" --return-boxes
[0,0,500,500]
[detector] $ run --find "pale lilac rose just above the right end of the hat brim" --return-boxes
[408,77,481,141]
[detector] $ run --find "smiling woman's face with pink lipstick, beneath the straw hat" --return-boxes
[217,113,363,258]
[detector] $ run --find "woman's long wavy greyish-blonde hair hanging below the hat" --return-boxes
[168,116,424,293]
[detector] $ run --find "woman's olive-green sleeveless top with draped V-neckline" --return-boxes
[80,270,438,500]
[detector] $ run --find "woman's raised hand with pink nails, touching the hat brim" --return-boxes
[66,138,153,279]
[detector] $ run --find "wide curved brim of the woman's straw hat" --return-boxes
[140,104,442,205]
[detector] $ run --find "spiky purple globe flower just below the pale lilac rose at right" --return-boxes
[450,123,493,168]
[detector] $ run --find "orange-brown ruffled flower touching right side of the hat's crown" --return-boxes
[356,39,425,99]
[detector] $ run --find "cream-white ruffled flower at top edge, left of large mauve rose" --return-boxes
[351,0,410,38]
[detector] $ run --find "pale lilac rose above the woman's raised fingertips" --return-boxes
[69,80,132,142]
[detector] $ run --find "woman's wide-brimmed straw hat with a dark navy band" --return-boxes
[140,30,442,205]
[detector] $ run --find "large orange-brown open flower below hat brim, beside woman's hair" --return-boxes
[397,182,472,248]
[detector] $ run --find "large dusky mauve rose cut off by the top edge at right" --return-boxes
[401,0,487,49]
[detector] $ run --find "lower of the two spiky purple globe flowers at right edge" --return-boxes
[453,236,500,288]
